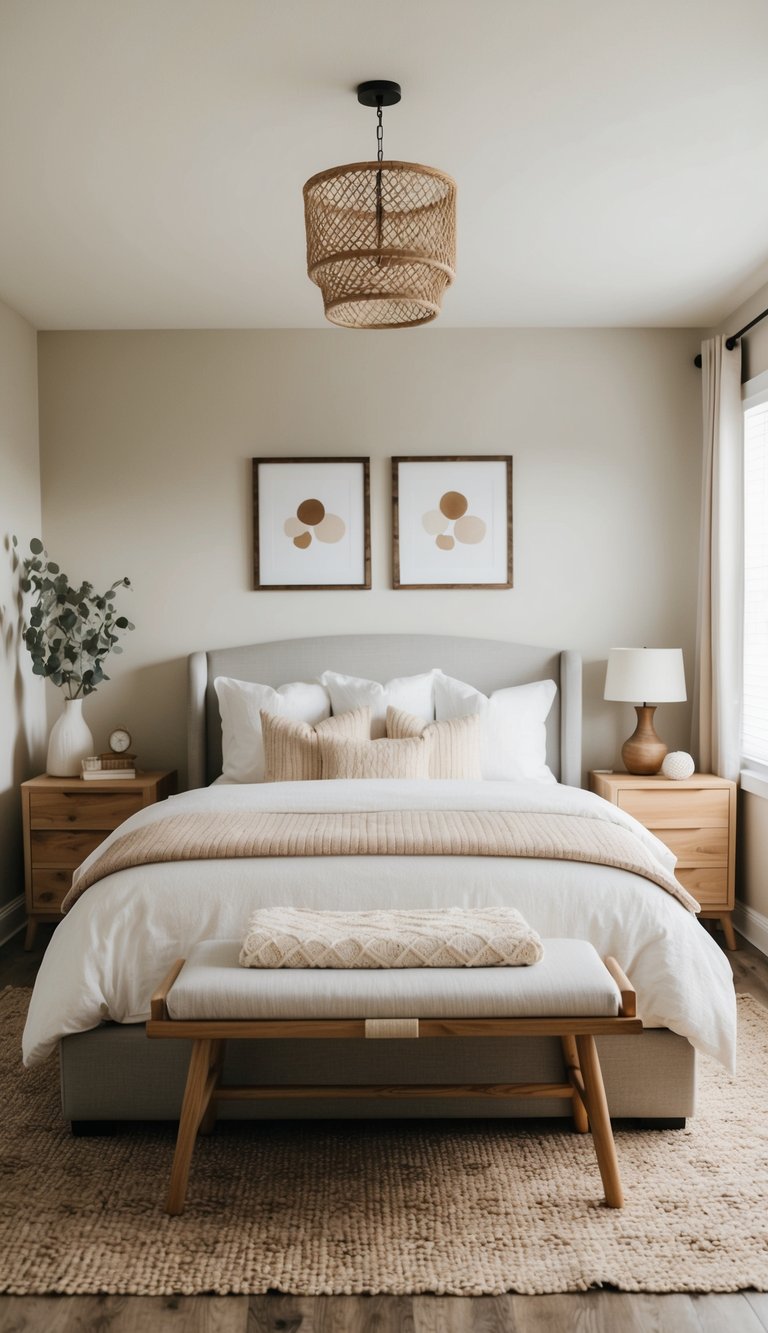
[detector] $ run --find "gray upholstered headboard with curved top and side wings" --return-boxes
[187,635,581,786]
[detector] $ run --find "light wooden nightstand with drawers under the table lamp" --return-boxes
[589,773,736,949]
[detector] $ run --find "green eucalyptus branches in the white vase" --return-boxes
[13,537,136,698]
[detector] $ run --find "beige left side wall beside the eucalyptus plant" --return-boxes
[0,303,45,940]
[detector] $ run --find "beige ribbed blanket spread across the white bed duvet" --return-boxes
[61,810,699,912]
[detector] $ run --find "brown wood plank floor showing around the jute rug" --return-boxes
[0,926,768,1333]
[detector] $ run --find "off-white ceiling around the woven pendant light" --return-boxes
[0,0,768,336]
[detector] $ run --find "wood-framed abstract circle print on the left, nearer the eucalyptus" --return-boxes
[253,459,371,591]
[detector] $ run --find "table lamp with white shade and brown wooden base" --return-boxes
[603,648,687,773]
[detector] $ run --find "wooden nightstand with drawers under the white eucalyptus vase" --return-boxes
[21,772,176,949]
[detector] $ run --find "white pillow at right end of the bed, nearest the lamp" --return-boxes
[435,670,557,782]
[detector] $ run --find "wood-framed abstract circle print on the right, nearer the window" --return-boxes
[392,455,512,588]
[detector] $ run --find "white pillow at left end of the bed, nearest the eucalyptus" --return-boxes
[213,676,331,782]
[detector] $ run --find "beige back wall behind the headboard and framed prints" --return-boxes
[39,329,700,768]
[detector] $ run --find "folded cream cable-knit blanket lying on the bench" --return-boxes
[240,908,544,968]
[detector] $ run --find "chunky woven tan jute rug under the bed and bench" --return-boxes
[0,989,768,1296]
